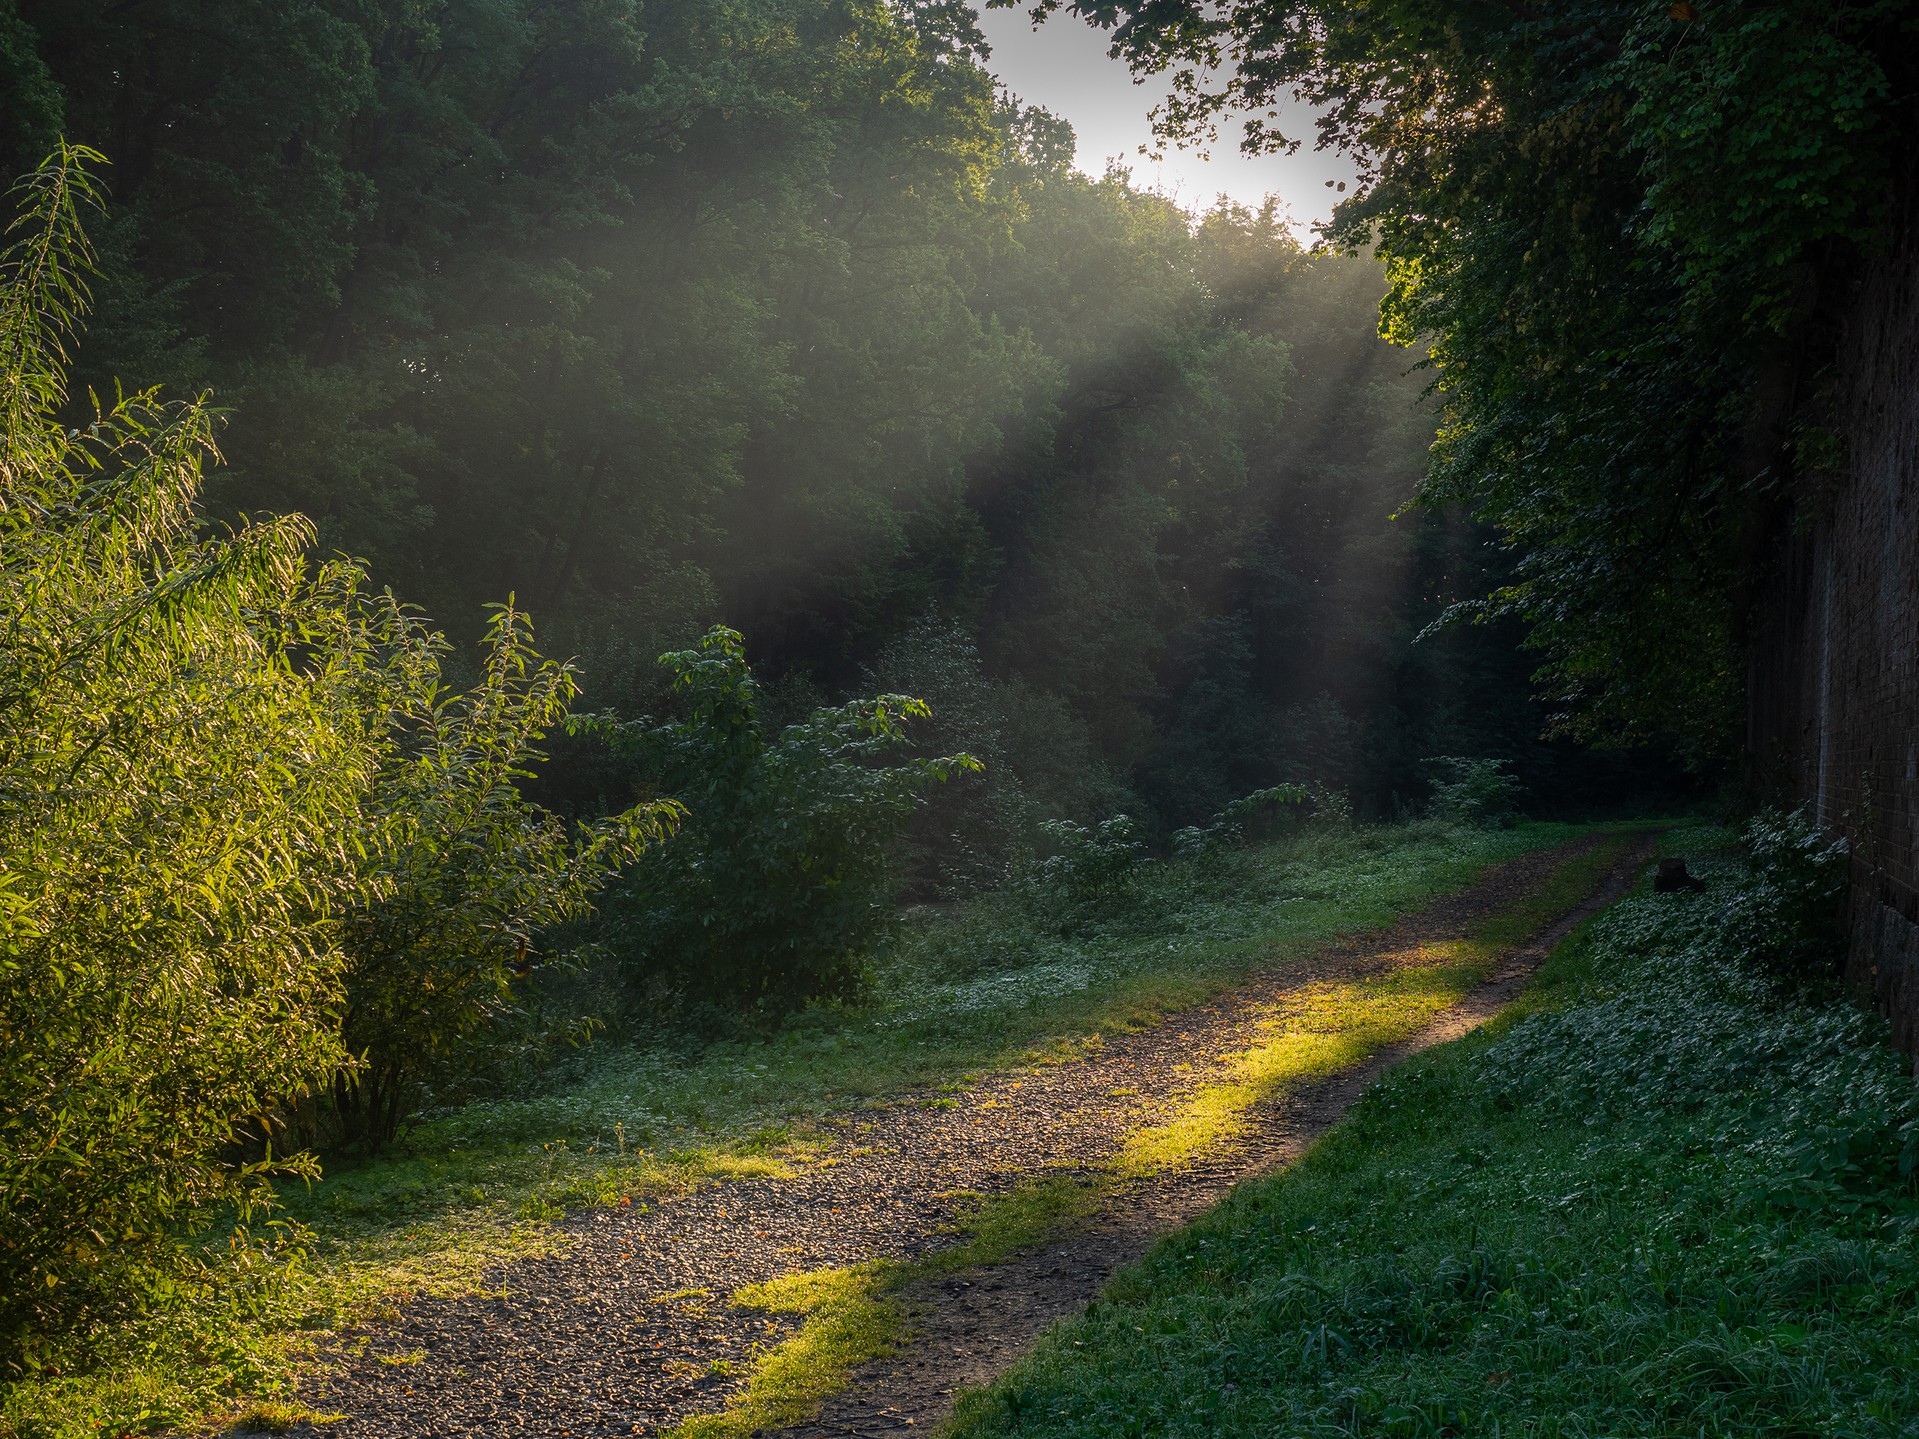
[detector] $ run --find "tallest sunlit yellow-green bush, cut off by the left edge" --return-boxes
[0,148,372,1364]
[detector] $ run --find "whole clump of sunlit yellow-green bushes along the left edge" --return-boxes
[0,148,672,1366]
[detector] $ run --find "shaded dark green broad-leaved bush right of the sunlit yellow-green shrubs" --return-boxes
[601,627,981,1011]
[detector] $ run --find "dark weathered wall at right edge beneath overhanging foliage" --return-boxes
[1748,160,1919,1051]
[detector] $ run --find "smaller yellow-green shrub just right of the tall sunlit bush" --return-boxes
[332,597,679,1145]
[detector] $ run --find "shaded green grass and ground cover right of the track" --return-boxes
[956,819,1919,1439]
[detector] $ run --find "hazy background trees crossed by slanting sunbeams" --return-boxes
[0,0,1681,829]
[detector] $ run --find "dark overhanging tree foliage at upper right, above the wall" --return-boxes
[1066,0,1919,756]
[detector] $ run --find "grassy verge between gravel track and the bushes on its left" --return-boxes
[0,825,1634,1439]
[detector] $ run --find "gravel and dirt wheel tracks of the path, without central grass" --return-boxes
[287,837,1650,1439]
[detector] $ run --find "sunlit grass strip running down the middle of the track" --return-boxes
[672,835,1635,1439]
